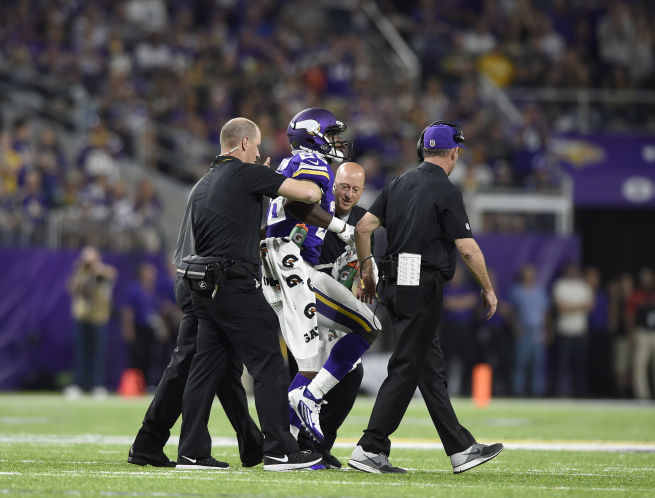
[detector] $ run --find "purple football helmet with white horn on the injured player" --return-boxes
[287,107,352,163]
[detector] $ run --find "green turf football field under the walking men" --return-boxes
[0,394,655,497]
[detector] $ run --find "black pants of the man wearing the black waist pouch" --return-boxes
[178,278,298,458]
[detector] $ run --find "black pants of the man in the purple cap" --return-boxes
[358,272,475,455]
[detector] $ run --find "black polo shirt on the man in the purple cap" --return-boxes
[369,162,473,280]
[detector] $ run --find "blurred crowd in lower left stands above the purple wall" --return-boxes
[0,116,162,251]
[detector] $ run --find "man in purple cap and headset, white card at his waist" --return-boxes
[349,121,503,474]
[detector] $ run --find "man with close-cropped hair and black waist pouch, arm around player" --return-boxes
[177,118,322,470]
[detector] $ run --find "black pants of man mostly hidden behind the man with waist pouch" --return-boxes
[134,277,263,463]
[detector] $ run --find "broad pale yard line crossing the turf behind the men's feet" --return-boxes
[0,434,655,453]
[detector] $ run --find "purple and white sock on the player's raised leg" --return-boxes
[307,333,370,399]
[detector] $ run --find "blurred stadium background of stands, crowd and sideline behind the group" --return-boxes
[0,0,655,399]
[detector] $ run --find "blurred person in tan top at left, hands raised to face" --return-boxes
[64,246,117,396]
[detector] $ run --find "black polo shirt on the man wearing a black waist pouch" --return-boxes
[178,156,286,266]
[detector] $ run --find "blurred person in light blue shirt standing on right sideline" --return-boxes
[510,264,550,396]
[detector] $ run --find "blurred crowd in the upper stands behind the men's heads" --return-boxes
[0,0,655,200]
